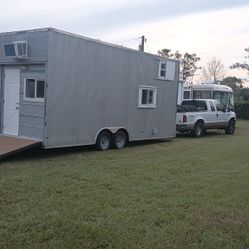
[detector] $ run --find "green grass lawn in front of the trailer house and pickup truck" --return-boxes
[0,121,249,249]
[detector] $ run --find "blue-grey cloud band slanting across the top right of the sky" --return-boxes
[63,0,249,33]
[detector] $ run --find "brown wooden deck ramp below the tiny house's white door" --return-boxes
[0,135,41,159]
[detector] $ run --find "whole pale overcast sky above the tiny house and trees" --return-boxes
[0,0,249,83]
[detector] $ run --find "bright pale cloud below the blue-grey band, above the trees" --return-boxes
[100,6,249,80]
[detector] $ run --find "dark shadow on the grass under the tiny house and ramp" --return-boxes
[0,139,172,163]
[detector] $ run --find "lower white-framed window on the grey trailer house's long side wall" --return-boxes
[138,86,157,108]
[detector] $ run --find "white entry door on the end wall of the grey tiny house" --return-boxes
[3,67,20,136]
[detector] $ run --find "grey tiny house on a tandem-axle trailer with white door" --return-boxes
[0,28,179,153]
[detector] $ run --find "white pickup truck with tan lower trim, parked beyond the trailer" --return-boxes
[176,99,236,137]
